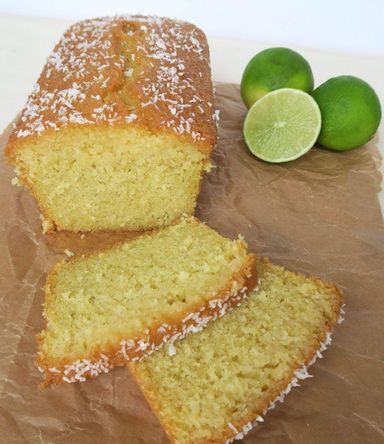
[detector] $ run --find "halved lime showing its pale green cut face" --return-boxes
[244,88,321,163]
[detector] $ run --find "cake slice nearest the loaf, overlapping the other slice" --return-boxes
[37,218,257,385]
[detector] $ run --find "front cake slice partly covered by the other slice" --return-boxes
[129,260,342,444]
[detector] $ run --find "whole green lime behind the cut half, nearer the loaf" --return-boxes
[241,48,313,108]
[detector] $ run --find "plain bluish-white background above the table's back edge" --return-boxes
[0,0,384,56]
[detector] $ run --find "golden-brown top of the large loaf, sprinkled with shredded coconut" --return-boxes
[10,16,218,152]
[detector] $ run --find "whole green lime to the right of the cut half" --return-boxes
[313,76,381,151]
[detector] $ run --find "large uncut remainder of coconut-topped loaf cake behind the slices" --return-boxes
[6,16,217,231]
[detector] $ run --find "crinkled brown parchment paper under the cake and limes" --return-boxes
[0,85,384,444]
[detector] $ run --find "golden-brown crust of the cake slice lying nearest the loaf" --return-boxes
[35,217,258,387]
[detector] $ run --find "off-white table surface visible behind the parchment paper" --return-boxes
[0,14,384,209]
